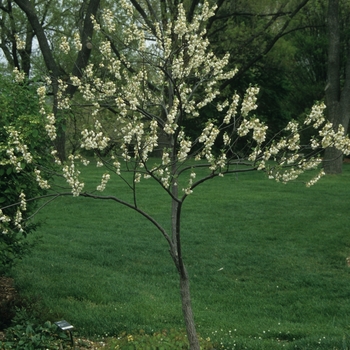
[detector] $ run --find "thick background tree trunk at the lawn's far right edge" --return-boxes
[324,0,350,174]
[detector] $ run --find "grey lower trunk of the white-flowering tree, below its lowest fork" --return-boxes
[180,266,200,350]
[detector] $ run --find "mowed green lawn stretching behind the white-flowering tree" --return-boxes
[9,164,350,349]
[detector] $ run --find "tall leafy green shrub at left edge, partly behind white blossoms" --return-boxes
[0,75,53,274]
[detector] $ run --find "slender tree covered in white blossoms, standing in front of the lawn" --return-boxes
[0,0,350,350]
